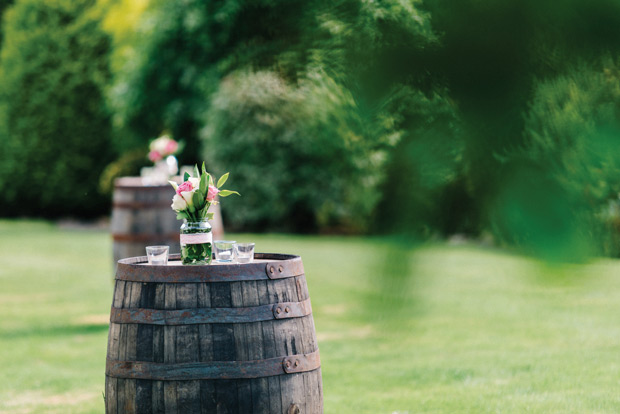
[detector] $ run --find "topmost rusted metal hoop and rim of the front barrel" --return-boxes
[116,253,304,283]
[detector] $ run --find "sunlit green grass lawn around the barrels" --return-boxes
[0,221,620,414]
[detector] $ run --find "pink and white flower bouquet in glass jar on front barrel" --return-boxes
[169,162,240,265]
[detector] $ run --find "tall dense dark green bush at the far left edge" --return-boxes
[0,0,112,217]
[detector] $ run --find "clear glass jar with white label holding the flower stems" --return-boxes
[181,219,213,265]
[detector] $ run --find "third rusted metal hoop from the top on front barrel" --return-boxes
[106,350,321,381]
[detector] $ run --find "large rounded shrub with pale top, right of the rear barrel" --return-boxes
[204,72,383,231]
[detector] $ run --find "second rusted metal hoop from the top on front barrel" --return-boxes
[110,298,312,325]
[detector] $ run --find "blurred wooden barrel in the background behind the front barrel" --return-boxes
[110,177,223,265]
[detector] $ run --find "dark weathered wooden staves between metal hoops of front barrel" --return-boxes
[106,258,323,414]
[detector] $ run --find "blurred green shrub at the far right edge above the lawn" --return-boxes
[515,61,620,255]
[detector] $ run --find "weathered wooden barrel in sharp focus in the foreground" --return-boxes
[105,253,323,414]
